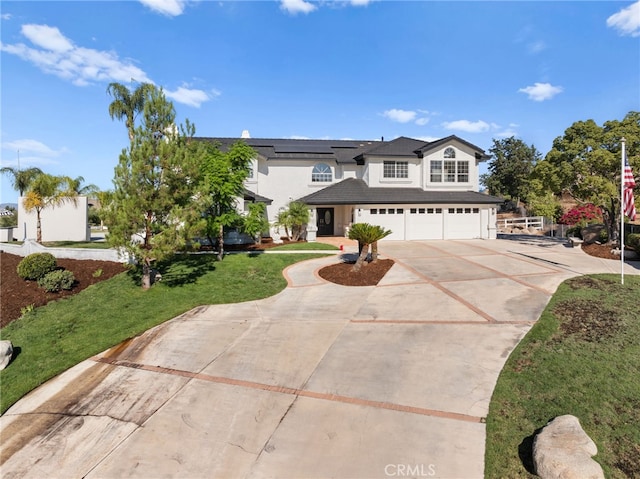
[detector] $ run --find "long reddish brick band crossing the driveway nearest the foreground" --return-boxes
[93,358,485,423]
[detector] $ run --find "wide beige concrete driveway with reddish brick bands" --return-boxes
[0,238,638,479]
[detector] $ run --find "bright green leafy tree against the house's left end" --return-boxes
[199,141,255,260]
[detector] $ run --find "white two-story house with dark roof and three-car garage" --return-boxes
[201,135,502,241]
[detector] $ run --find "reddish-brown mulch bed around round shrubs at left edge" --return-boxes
[0,252,126,327]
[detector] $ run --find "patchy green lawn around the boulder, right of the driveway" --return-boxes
[485,275,640,479]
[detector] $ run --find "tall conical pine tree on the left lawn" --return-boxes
[107,87,199,289]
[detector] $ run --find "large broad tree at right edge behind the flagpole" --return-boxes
[533,111,640,242]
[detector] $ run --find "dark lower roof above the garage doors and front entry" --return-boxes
[299,178,503,205]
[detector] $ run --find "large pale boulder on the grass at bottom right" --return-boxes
[533,414,604,479]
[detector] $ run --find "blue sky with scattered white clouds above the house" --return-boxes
[0,0,640,202]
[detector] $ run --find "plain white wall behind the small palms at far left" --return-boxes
[15,196,91,241]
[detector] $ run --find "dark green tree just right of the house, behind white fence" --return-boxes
[481,136,541,201]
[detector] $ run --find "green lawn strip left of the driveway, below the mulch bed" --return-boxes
[0,254,328,414]
